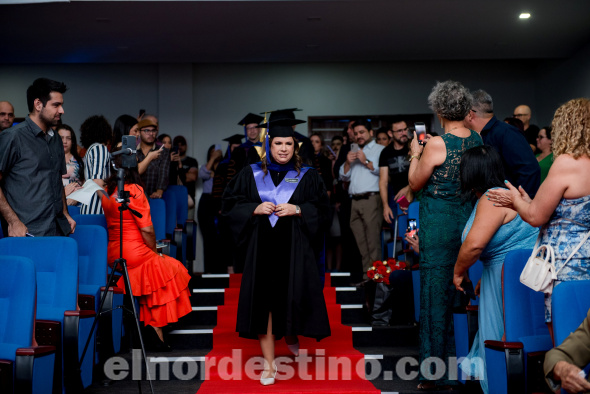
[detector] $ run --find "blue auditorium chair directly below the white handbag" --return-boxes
[485,249,553,394]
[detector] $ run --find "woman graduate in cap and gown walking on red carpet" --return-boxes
[222,119,330,385]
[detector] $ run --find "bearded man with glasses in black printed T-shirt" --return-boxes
[379,120,413,223]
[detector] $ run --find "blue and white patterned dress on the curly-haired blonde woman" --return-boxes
[539,195,590,322]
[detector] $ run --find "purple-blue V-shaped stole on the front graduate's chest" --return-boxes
[250,164,309,227]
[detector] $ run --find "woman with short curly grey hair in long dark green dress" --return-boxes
[408,81,482,390]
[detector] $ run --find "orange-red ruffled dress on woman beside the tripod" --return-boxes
[102,184,192,327]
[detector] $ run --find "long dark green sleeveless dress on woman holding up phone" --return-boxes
[420,130,482,385]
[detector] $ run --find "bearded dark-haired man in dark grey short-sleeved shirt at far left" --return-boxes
[0,78,76,237]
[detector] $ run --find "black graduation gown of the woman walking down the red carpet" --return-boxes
[222,166,330,340]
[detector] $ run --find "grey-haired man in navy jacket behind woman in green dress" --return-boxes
[465,90,541,198]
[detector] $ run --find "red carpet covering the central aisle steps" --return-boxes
[198,275,380,394]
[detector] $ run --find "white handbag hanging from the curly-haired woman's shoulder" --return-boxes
[520,232,590,294]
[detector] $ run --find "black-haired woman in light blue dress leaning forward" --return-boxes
[453,145,539,394]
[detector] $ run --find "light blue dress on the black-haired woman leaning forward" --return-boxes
[460,195,539,394]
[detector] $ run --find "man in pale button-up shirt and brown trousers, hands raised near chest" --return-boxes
[340,120,384,278]
